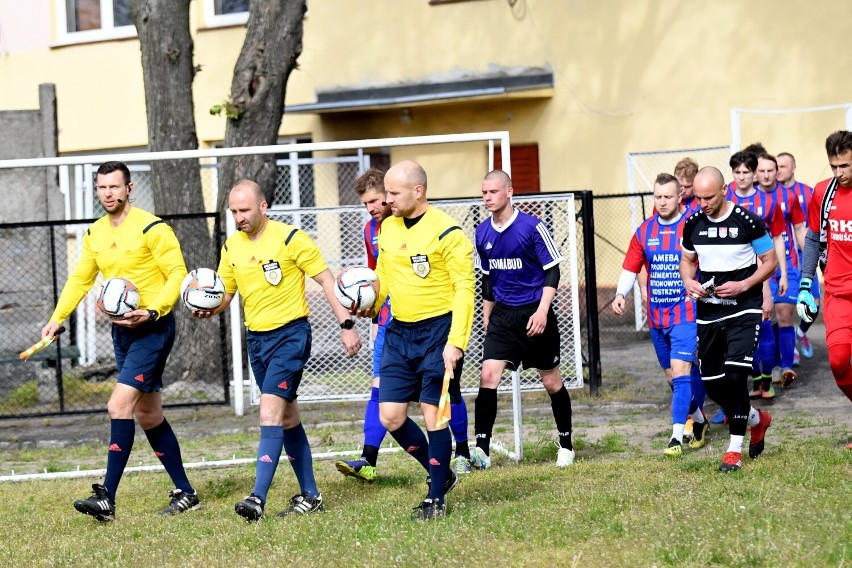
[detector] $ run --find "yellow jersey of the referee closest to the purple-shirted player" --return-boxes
[376,205,475,350]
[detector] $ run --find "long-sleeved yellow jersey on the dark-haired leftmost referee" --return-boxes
[50,207,186,323]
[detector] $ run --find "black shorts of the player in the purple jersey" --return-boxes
[482,302,560,371]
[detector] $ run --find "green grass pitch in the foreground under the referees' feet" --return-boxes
[0,426,852,567]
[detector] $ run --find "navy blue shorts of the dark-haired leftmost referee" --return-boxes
[112,313,175,393]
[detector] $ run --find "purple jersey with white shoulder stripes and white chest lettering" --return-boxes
[476,209,565,306]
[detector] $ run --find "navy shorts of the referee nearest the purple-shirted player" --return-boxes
[379,314,463,404]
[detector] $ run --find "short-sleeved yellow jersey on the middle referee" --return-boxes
[219,219,328,331]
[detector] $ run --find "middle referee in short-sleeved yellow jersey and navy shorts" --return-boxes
[194,180,361,521]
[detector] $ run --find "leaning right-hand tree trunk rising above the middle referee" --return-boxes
[219,0,307,211]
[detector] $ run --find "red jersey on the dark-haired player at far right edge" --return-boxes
[808,179,852,295]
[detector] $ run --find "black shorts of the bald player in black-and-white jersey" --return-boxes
[698,311,762,381]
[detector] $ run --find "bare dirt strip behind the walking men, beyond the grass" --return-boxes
[0,324,852,458]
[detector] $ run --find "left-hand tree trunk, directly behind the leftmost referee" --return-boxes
[130,0,223,382]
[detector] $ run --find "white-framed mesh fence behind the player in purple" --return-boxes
[262,194,583,401]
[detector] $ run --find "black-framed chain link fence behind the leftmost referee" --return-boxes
[0,214,229,417]
